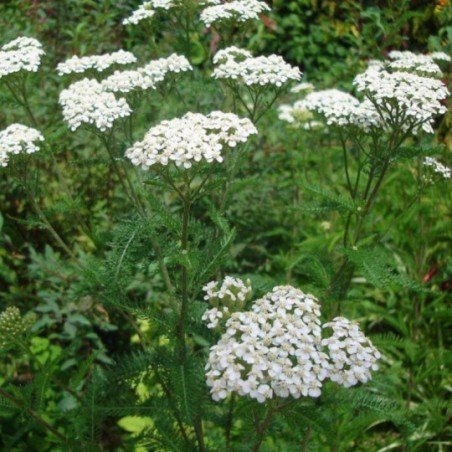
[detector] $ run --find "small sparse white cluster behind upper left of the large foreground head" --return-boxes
[202,276,252,328]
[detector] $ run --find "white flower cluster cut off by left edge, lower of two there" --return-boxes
[0,124,44,166]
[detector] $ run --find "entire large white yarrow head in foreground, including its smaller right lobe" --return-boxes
[205,278,380,402]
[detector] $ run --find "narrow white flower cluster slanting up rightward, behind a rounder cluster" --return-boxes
[102,53,193,93]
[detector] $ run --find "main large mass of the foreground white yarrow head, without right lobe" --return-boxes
[206,286,330,402]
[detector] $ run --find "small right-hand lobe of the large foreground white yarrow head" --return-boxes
[322,317,381,388]
